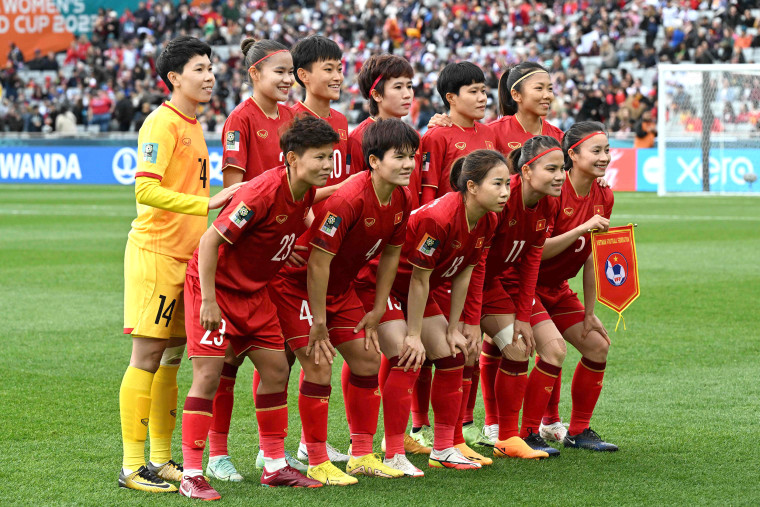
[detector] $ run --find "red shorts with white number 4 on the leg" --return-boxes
[268,277,366,350]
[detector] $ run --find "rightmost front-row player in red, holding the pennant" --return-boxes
[536,122,617,451]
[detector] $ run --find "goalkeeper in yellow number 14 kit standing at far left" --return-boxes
[119,36,243,493]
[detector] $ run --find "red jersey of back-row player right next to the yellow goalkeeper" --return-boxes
[222,97,293,181]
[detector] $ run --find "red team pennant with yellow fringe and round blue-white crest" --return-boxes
[591,224,639,331]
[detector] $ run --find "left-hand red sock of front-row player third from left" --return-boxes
[381,356,420,458]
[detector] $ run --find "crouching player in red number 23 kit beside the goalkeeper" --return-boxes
[179,117,338,500]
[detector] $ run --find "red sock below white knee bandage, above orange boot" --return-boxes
[495,358,528,440]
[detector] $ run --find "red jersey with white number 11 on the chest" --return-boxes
[466,174,559,322]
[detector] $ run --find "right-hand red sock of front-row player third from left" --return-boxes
[430,354,464,451]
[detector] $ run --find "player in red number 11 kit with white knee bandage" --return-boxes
[476,136,565,458]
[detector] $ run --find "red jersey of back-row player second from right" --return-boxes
[422,122,496,198]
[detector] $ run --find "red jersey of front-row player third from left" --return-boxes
[386,192,498,300]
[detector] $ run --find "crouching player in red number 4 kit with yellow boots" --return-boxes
[270,120,419,485]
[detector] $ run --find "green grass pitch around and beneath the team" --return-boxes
[0,185,760,506]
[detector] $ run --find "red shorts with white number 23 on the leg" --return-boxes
[185,276,285,358]
